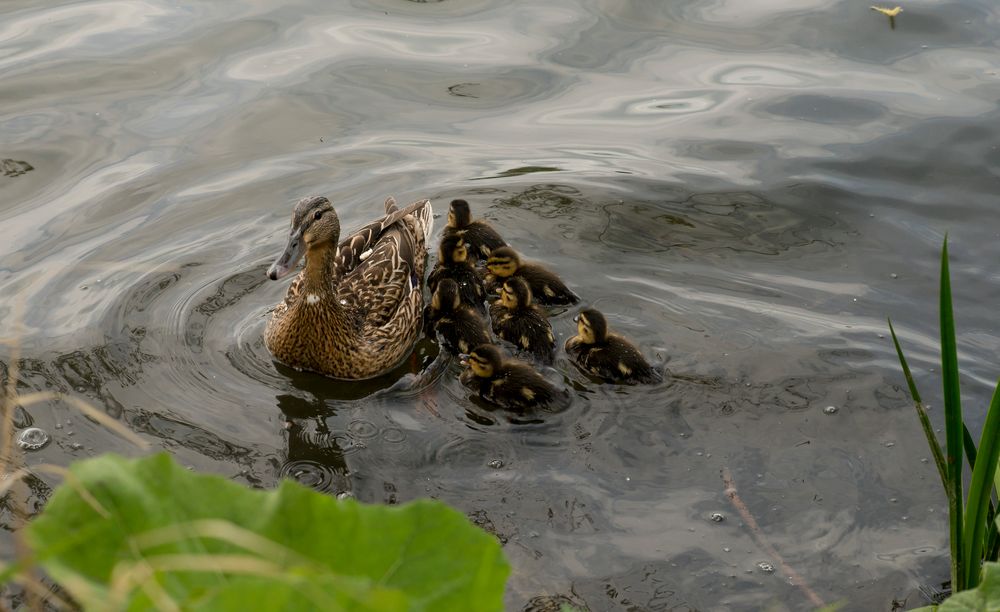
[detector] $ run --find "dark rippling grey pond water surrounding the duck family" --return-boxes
[0,0,1000,610]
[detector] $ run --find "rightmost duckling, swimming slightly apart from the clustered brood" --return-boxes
[566,308,662,383]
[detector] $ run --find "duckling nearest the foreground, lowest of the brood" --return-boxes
[459,344,565,410]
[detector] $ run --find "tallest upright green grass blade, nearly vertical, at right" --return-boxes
[940,236,964,592]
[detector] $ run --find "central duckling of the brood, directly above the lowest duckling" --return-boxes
[490,276,556,363]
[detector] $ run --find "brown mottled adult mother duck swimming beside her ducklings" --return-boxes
[264,196,433,379]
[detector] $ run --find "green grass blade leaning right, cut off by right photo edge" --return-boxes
[964,383,1000,588]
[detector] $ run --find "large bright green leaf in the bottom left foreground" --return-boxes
[27,454,509,611]
